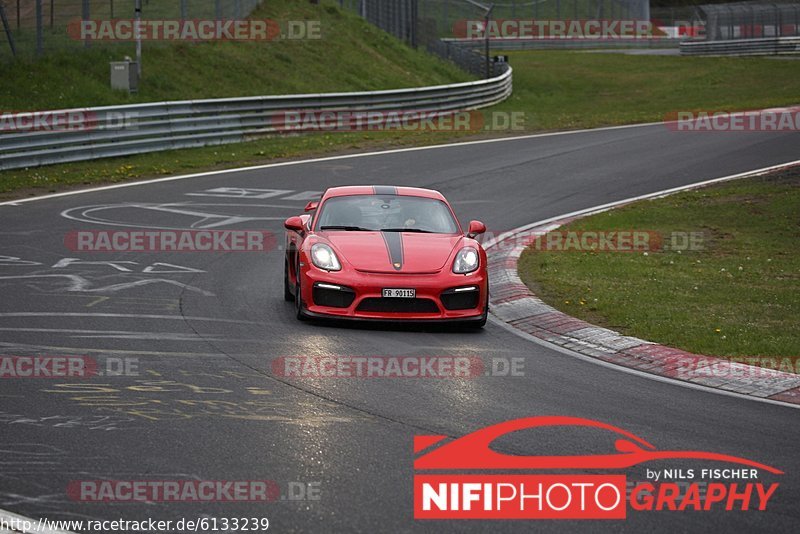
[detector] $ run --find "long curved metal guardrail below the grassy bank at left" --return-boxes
[0,66,512,170]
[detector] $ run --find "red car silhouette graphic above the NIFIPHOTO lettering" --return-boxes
[414,416,783,475]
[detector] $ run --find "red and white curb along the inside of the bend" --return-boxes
[485,161,800,405]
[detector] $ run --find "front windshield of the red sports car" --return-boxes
[316,195,458,234]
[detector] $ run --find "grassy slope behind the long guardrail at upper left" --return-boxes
[0,0,471,110]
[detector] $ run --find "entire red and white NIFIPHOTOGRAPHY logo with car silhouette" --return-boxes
[414,416,783,519]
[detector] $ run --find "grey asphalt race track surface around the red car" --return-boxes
[0,125,800,532]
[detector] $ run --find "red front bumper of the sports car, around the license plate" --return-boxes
[300,267,488,322]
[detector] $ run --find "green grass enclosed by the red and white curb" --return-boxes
[519,167,800,358]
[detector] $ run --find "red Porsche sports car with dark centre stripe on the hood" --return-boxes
[284,186,489,328]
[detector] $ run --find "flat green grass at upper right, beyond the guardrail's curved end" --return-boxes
[490,51,800,130]
